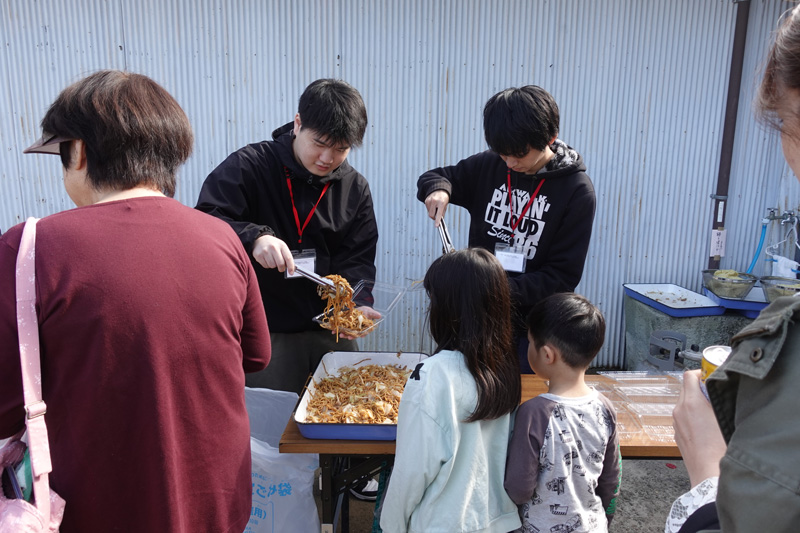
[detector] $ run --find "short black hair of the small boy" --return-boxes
[527,292,606,368]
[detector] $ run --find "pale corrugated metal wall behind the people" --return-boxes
[0,0,800,366]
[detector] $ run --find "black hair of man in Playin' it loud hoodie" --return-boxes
[483,85,559,157]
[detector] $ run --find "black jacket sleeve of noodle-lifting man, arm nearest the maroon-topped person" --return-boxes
[195,147,275,254]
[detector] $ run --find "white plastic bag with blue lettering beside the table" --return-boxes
[245,388,320,533]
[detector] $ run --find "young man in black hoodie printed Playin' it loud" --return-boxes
[417,85,595,372]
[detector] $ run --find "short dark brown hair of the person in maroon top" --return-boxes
[42,70,194,197]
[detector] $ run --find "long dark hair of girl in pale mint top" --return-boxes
[423,248,522,422]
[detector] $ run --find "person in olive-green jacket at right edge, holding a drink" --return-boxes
[665,6,800,533]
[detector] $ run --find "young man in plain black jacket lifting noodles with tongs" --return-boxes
[197,79,380,394]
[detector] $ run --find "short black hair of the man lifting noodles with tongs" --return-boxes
[297,78,367,146]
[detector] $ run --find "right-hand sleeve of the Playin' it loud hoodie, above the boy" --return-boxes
[509,177,596,308]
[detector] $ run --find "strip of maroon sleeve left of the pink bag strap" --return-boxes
[0,225,25,439]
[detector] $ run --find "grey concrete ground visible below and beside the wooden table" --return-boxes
[316,459,690,533]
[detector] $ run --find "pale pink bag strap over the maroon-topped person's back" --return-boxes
[16,217,53,521]
